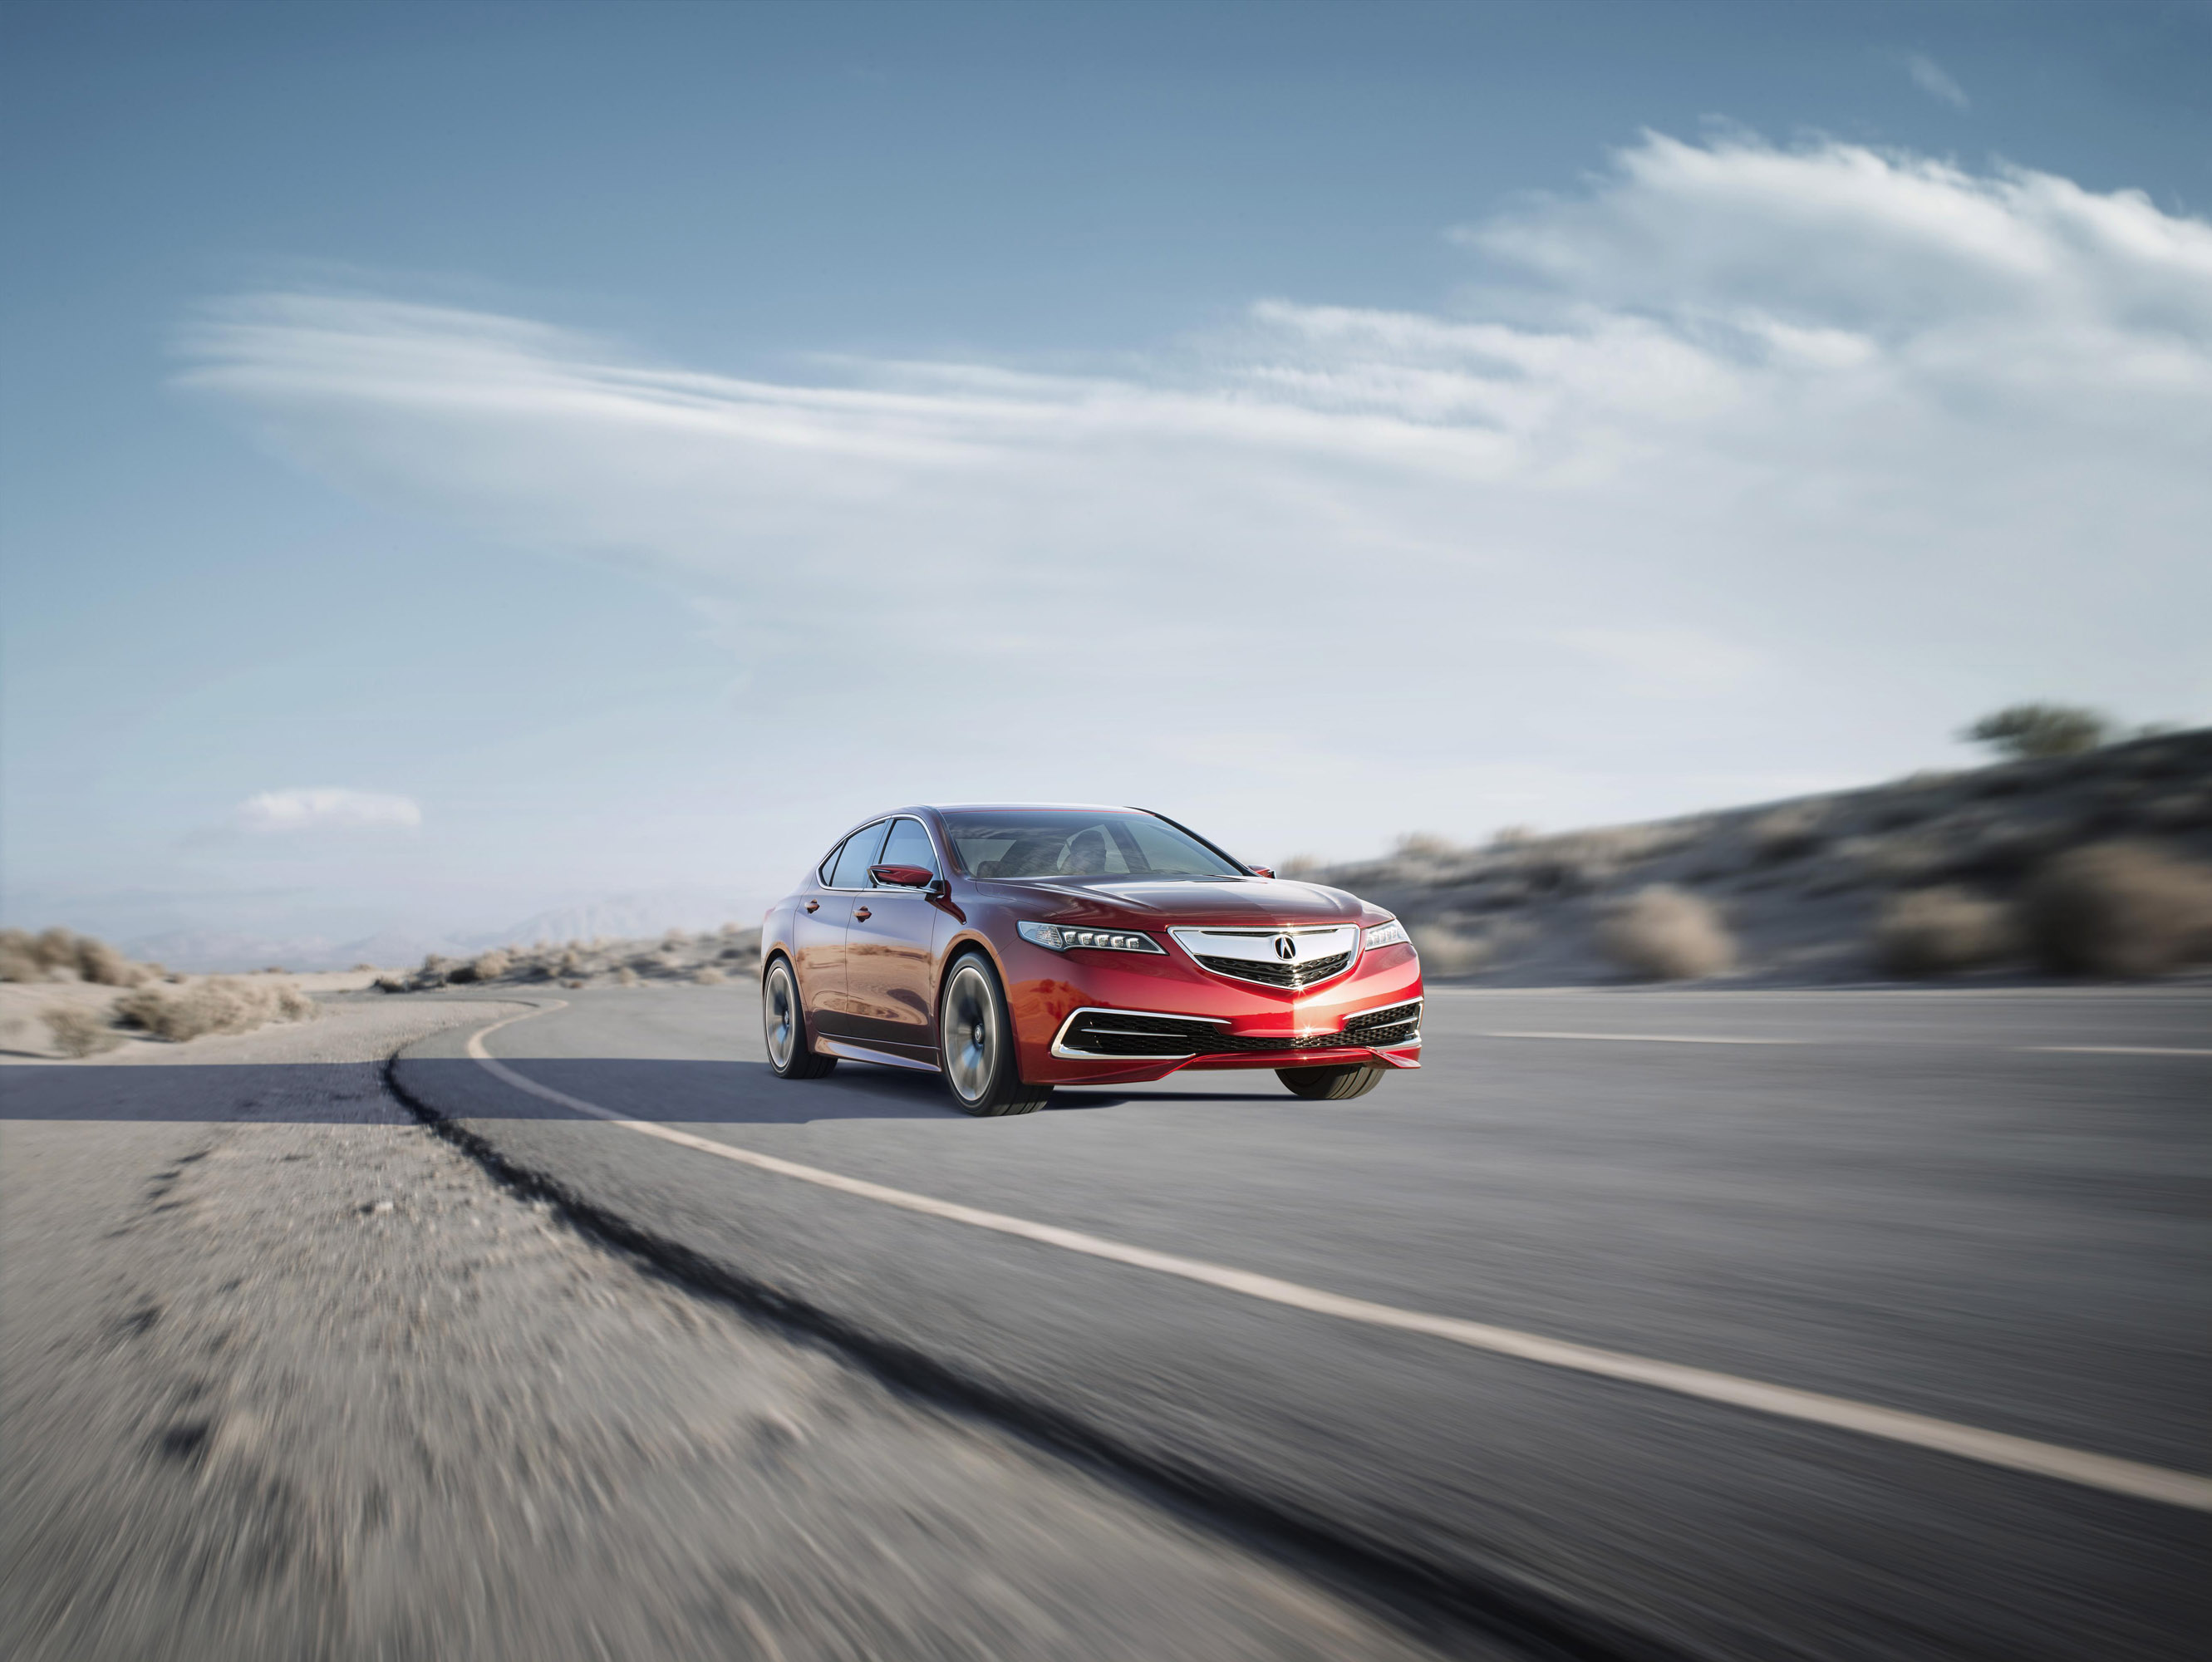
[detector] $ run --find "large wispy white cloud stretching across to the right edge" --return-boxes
[184,135,2212,837]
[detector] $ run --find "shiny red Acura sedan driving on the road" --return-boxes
[761,805,1420,1114]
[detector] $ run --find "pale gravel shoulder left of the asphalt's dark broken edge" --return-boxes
[0,998,1471,1660]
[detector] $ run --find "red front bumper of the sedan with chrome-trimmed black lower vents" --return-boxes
[1006,942,1423,1084]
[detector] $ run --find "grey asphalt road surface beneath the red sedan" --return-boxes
[394,987,2212,1660]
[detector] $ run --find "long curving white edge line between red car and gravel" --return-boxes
[469,1011,2212,1512]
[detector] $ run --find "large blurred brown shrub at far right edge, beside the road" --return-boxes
[2022,843,2212,978]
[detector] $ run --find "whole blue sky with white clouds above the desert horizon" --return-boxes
[0,4,2212,956]
